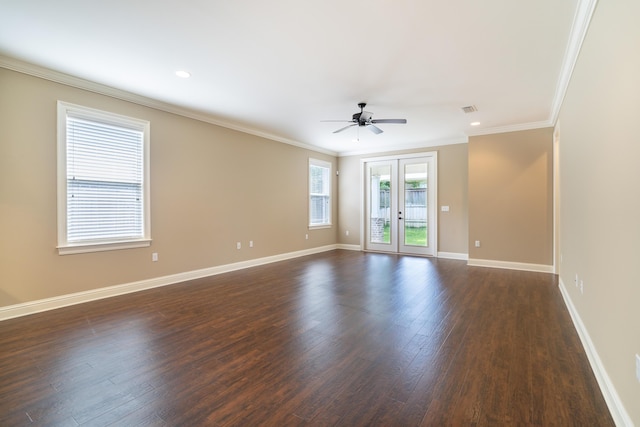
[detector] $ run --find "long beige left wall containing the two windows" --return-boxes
[0,68,337,306]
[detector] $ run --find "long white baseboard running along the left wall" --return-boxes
[0,245,339,321]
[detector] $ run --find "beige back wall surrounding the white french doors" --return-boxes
[338,144,468,255]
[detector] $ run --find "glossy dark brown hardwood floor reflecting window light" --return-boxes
[0,251,613,426]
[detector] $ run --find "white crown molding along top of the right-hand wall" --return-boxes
[549,0,598,125]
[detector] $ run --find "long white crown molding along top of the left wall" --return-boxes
[0,55,338,156]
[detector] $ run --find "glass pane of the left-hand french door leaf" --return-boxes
[369,165,391,244]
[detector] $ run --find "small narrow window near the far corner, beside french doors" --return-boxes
[309,159,331,227]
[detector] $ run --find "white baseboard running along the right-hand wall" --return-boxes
[559,278,633,427]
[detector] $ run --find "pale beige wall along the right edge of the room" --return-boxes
[558,0,640,425]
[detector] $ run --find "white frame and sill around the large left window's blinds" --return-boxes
[57,101,151,255]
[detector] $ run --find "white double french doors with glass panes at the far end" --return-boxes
[365,153,437,255]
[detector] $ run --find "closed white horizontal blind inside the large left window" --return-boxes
[67,115,144,242]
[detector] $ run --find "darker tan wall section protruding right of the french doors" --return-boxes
[469,128,553,266]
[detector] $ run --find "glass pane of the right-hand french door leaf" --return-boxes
[402,163,429,247]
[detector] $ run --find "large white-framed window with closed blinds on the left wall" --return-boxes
[58,101,151,255]
